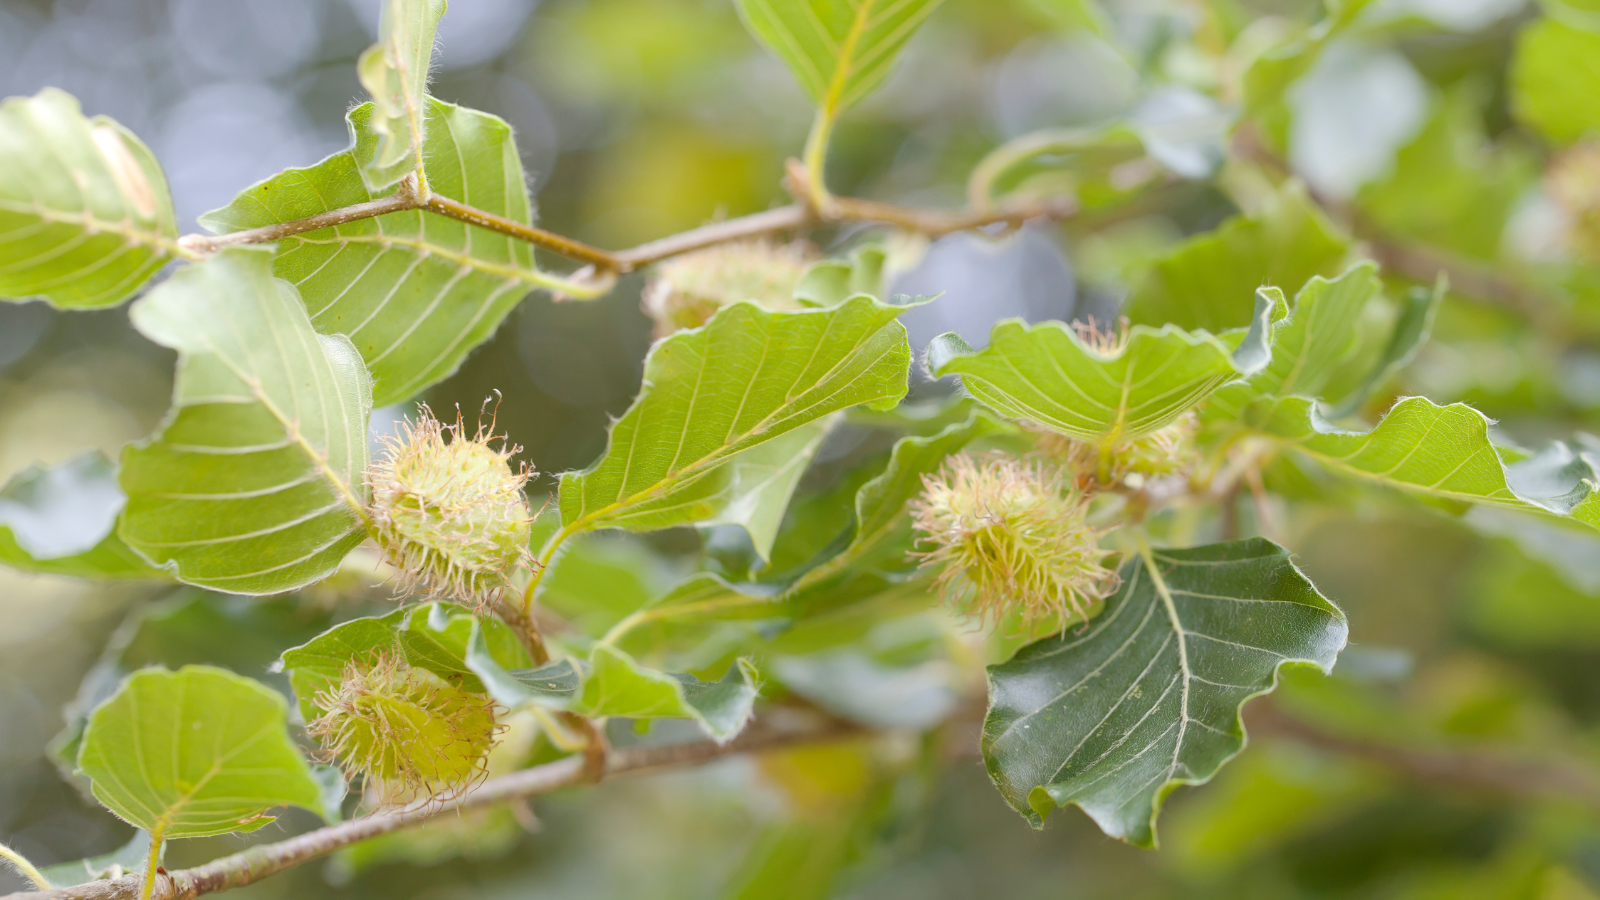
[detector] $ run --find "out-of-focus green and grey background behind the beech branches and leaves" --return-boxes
[9,0,1600,900]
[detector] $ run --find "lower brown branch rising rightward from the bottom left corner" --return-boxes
[0,717,864,900]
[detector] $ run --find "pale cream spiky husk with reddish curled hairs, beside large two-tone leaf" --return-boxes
[366,407,533,610]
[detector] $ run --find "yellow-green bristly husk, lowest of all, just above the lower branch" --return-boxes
[306,653,499,806]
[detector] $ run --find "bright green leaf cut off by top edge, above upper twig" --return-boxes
[738,0,939,119]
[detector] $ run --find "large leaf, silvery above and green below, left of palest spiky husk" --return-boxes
[120,247,371,594]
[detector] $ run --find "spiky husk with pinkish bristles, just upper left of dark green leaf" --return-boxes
[912,455,1117,631]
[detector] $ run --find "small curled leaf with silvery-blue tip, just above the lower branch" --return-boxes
[578,644,760,741]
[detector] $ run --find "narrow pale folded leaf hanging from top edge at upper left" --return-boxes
[355,0,445,191]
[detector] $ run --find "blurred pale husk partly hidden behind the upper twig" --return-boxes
[642,239,816,338]
